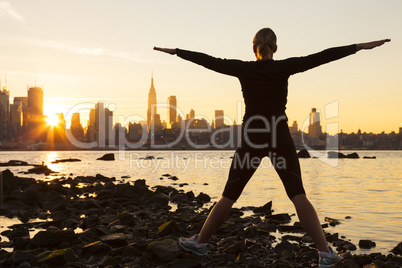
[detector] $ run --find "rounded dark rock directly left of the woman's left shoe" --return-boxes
[147,238,180,262]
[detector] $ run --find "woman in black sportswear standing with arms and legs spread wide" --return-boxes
[154,28,390,267]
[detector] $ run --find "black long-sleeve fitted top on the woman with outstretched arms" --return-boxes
[176,45,357,115]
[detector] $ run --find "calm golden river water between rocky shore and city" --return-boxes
[0,151,402,254]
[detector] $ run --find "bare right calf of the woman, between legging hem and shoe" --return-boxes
[292,194,329,253]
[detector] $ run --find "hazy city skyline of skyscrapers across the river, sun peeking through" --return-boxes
[0,72,402,150]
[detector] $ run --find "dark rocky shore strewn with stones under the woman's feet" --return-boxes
[0,170,402,268]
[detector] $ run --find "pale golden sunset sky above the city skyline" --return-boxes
[0,0,402,133]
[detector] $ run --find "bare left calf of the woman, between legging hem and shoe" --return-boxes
[197,196,234,243]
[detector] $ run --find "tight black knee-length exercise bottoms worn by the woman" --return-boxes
[222,114,305,201]
